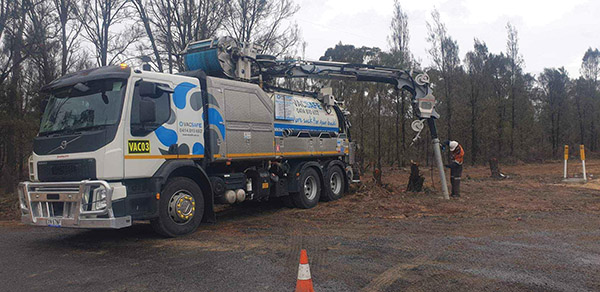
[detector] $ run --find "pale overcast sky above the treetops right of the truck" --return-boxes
[294,0,600,78]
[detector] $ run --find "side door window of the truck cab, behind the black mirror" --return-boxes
[131,84,171,137]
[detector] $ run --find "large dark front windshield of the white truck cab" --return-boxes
[40,79,127,135]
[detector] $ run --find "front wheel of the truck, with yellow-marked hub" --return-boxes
[150,177,204,237]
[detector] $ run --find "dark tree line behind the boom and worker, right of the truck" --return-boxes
[321,1,600,175]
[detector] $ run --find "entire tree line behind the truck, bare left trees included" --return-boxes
[0,0,600,191]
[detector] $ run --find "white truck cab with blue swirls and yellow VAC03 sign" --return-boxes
[18,65,216,233]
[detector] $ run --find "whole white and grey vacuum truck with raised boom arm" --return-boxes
[18,37,443,237]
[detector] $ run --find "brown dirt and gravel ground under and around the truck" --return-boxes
[0,161,600,291]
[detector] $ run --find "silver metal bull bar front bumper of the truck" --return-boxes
[18,180,132,229]
